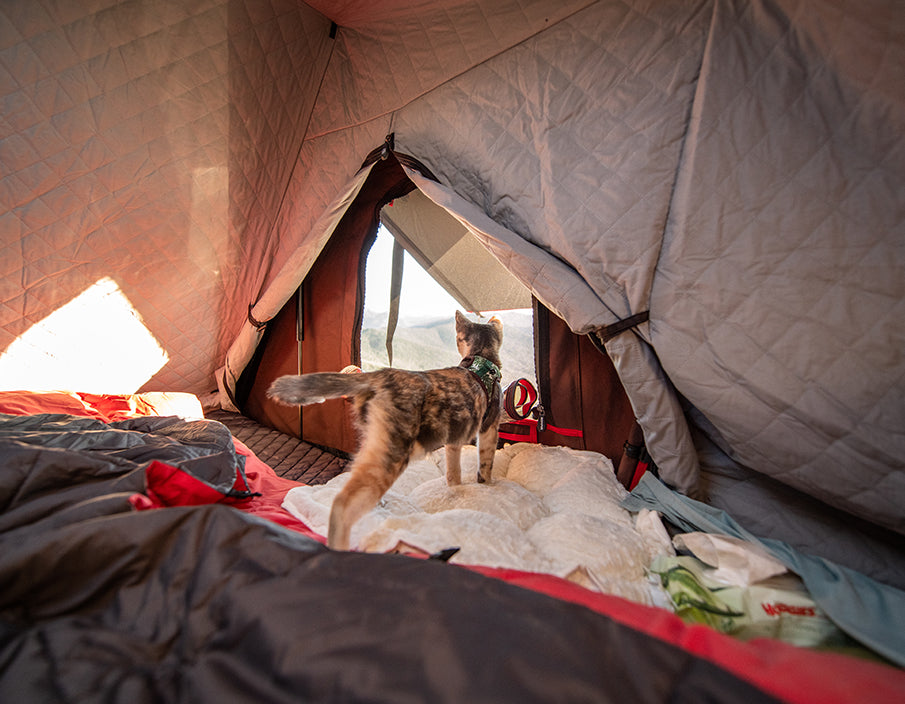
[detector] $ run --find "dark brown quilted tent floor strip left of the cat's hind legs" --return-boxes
[205,409,349,484]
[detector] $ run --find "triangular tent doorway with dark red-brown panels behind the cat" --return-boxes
[236,150,634,463]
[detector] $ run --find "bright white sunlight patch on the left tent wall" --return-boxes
[0,277,169,393]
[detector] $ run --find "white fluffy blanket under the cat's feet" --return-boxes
[283,444,674,605]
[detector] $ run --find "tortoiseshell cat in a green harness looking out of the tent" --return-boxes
[267,311,503,550]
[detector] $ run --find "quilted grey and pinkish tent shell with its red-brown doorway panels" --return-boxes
[0,0,905,701]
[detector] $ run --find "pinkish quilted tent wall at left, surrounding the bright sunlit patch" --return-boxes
[0,0,330,393]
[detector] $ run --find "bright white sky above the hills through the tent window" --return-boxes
[365,225,461,318]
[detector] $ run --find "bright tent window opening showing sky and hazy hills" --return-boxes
[361,226,536,386]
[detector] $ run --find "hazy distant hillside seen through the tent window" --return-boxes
[361,314,535,387]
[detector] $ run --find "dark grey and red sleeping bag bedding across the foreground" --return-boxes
[0,397,903,702]
